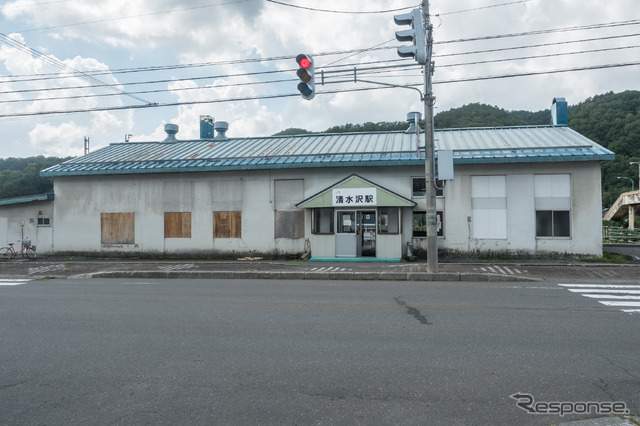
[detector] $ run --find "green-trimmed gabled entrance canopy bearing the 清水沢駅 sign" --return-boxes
[296,174,416,209]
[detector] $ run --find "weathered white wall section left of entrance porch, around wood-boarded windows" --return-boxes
[54,171,304,254]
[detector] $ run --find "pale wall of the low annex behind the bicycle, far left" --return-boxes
[0,201,54,254]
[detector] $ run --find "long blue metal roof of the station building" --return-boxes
[41,126,614,176]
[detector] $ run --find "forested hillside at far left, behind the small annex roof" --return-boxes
[0,155,71,199]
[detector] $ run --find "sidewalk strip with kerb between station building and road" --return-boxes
[0,258,640,282]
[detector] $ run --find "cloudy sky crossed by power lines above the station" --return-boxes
[0,0,640,158]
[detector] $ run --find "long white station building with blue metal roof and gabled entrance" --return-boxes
[22,98,614,260]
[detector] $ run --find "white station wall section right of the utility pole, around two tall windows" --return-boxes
[430,162,602,256]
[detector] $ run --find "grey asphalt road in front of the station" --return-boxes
[0,279,640,425]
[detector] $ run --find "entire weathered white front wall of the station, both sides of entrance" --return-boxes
[51,162,602,258]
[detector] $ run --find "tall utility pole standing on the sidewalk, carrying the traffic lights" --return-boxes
[422,0,438,273]
